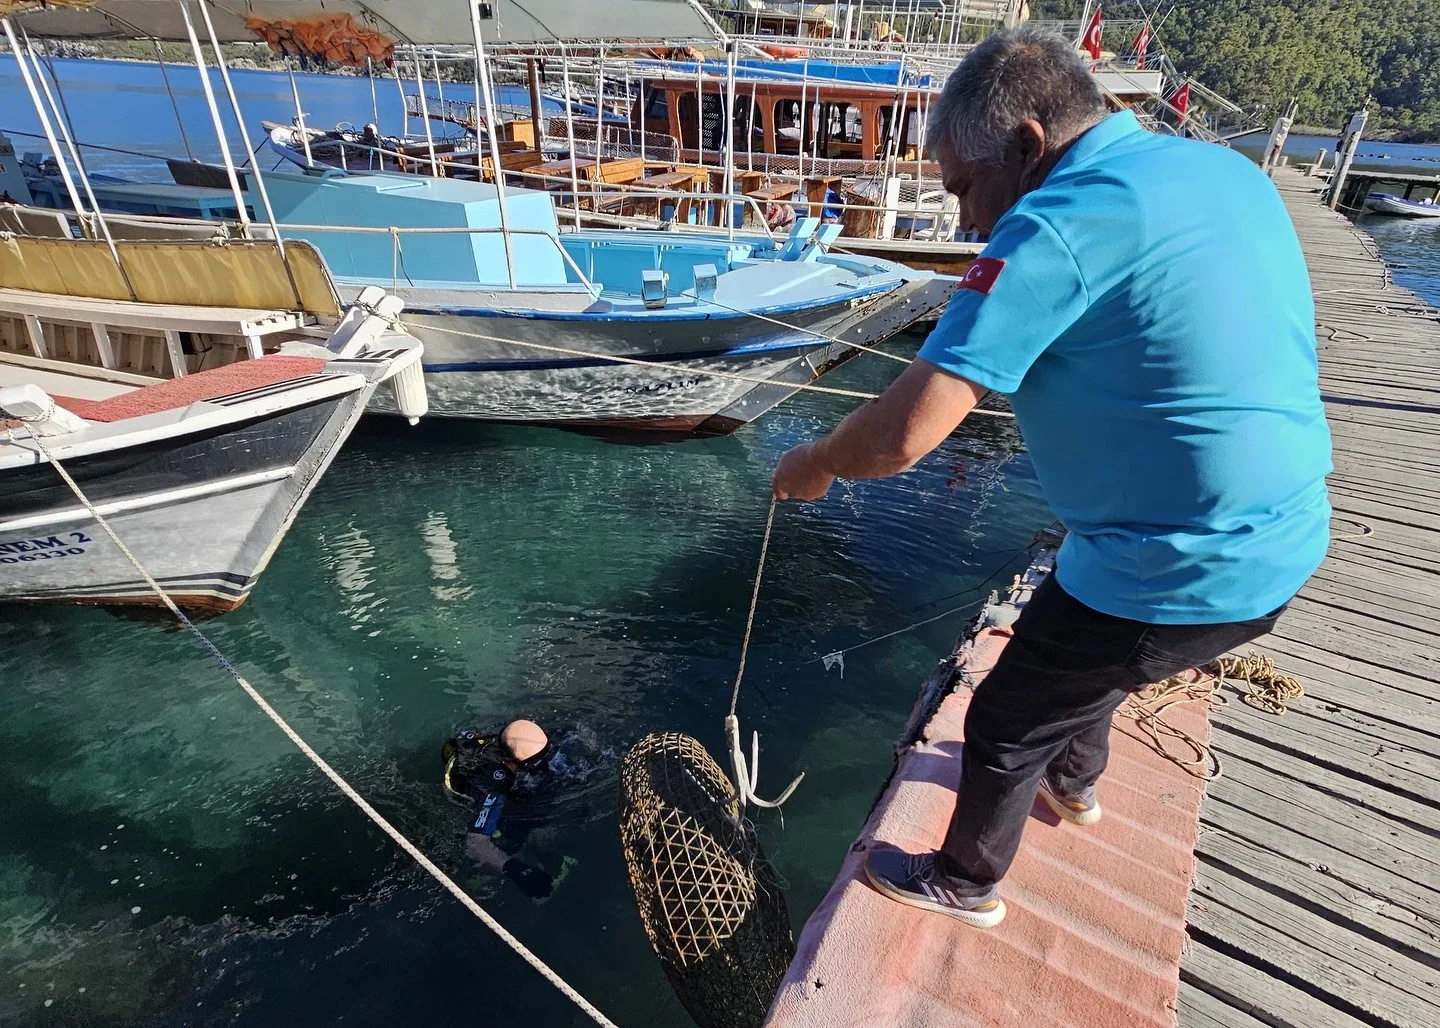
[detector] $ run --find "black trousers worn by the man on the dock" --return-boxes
[940,574,1284,893]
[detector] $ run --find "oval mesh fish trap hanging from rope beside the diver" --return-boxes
[621,731,795,1028]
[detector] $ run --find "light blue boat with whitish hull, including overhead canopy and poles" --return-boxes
[8,0,959,433]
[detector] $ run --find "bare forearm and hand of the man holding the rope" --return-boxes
[772,360,986,500]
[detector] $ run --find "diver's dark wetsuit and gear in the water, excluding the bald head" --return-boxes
[442,731,554,898]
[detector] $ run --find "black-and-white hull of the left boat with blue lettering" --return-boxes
[0,384,373,615]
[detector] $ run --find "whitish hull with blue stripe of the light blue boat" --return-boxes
[372,276,958,435]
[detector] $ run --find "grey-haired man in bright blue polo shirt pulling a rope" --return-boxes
[773,29,1331,927]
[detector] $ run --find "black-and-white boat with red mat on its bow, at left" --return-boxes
[0,282,425,615]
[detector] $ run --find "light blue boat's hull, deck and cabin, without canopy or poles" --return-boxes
[19,158,959,433]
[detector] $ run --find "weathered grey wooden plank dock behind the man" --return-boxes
[1179,168,1440,1028]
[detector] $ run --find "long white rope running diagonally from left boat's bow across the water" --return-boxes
[12,419,616,1028]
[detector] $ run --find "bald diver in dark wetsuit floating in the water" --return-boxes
[442,721,554,900]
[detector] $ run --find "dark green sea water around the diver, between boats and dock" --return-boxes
[0,337,1048,1025]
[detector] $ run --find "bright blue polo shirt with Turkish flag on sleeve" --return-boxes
[920,112,1331,625]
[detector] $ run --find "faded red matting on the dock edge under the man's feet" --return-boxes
[766,629,1210,1028]
